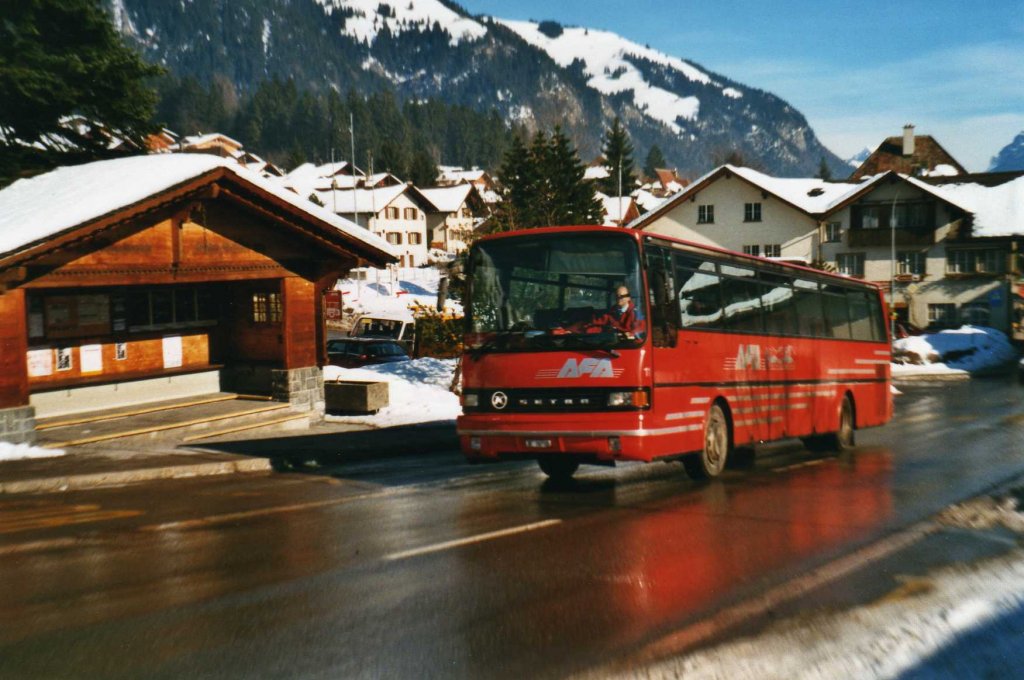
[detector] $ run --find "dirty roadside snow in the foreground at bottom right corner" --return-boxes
[631,497,1024,680]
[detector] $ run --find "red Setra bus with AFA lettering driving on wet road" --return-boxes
[458,226,892,479]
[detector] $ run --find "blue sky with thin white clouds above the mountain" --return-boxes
[459,0,1024,171]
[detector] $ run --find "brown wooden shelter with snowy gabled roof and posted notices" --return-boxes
[0,154,395,441]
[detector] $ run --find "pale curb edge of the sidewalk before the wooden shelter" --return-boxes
[0,458,270,494]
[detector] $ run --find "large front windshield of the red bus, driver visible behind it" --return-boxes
[467,232,647,352]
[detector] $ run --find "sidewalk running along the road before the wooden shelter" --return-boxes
[0,421,458,495]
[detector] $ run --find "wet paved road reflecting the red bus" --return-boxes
[0,380,1024,678]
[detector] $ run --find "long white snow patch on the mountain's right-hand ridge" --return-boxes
[496,19,712,134]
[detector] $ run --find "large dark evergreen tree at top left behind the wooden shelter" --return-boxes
[0,0,162,183]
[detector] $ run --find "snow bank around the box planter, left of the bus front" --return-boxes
[324,357,462,427]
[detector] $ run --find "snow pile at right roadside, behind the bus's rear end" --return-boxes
[893,326,1017,377]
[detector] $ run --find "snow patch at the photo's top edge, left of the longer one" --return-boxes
[316,0,487,45]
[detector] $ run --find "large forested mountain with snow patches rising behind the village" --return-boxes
[106,0,848,176]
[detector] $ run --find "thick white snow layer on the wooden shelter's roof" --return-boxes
[0,154,397,257]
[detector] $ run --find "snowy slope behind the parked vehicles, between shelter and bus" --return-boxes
[335,267,462,317]
